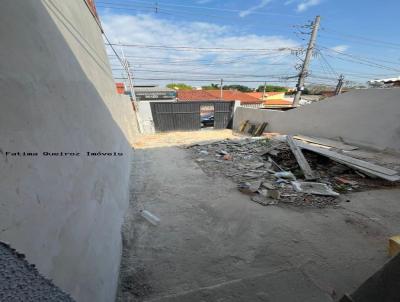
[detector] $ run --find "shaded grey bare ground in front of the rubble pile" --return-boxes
[118,133,400,302]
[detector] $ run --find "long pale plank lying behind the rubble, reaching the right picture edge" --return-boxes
[297,141,399,180]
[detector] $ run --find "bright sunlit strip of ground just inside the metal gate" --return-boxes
[133,129,238,149]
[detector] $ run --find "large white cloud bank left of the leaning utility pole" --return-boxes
[101,13,299,86]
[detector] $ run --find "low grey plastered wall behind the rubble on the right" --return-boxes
[234,88,400,152]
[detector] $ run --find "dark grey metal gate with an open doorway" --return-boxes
[150,101,234,132]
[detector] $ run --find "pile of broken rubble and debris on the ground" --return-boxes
[187,138,392,208]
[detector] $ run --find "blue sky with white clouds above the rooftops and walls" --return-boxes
[96,0,400,87]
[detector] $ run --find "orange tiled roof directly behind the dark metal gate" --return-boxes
[177,90,262,104]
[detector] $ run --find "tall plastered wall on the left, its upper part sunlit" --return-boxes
[0,0,135,301]
